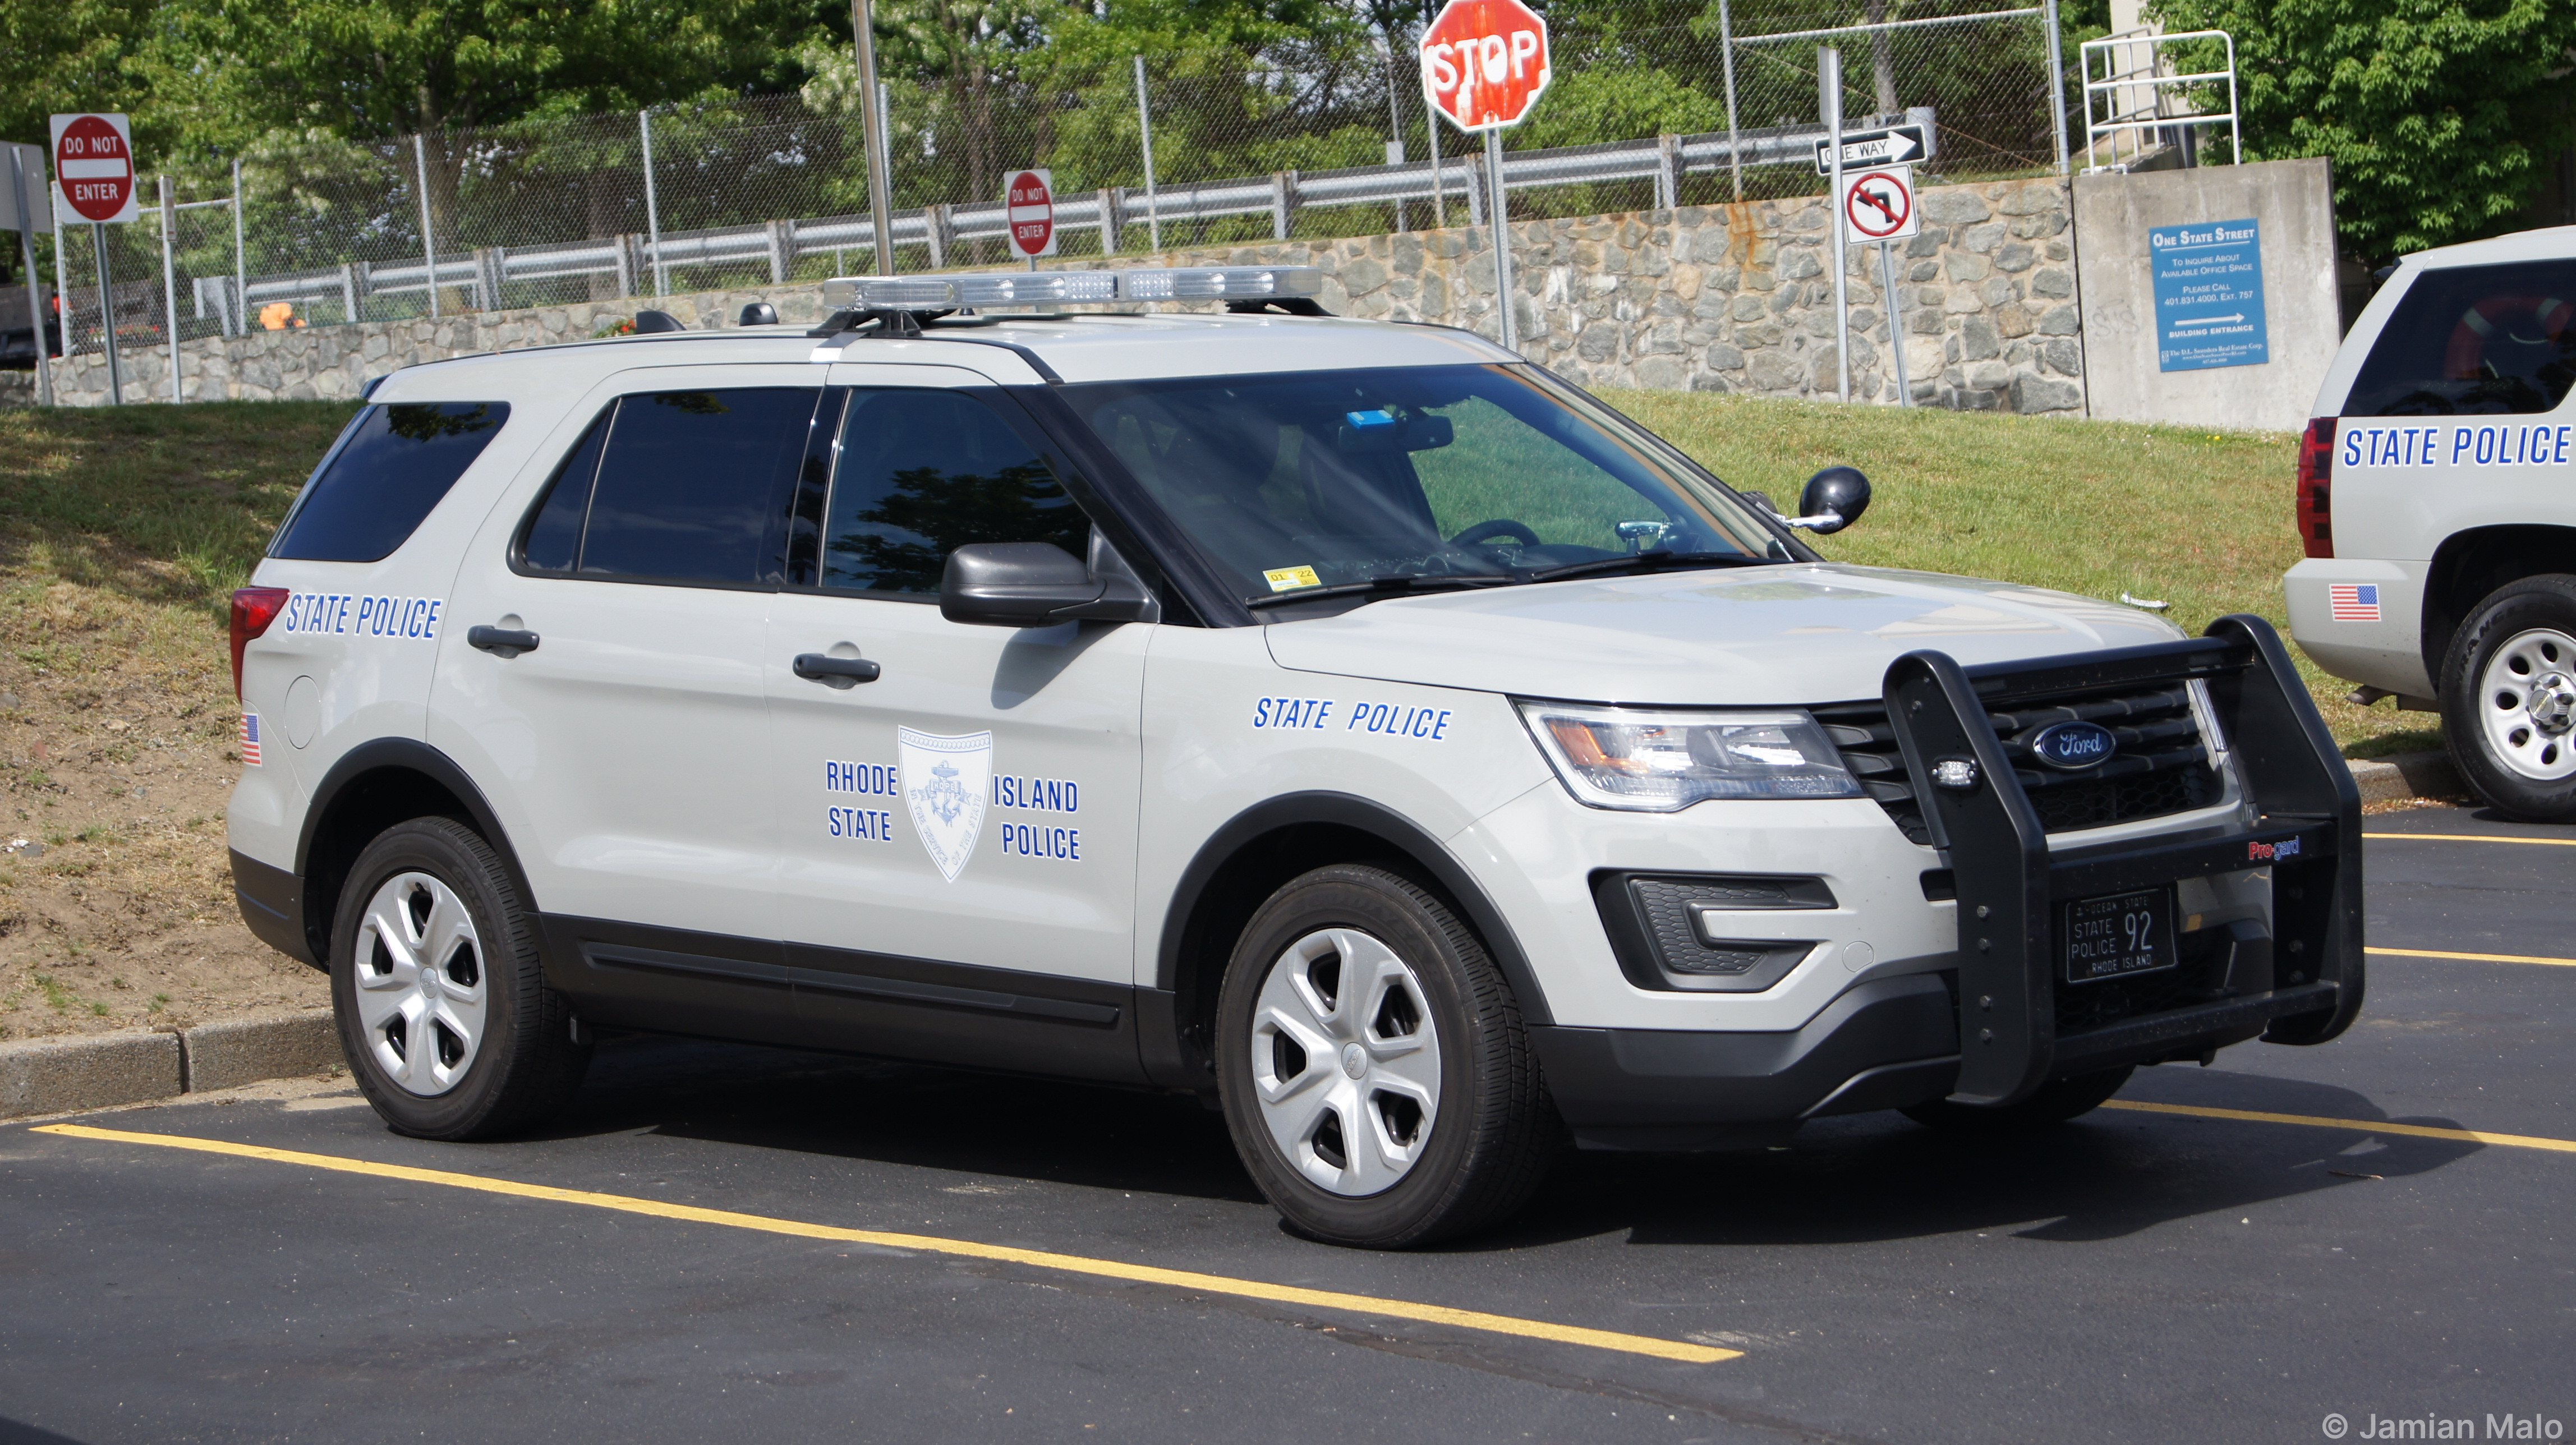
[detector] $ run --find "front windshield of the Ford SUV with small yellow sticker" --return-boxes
[1061,366,1788,602]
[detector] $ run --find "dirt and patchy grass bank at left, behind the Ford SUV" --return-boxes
[0,404,348,1038]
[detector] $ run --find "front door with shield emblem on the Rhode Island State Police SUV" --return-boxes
[762,366,1154,1076]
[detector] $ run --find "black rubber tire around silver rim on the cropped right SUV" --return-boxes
[2437,574,2576,822]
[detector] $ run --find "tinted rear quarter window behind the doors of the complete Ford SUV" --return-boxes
[268,402,510,562]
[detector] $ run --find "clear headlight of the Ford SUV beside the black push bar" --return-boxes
[1520,701,1862,814]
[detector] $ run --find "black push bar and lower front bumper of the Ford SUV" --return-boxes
[1533,615,2362,1149]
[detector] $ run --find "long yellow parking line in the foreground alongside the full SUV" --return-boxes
[34,1123,1744,1365]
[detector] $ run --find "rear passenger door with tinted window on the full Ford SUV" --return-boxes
[430,366,822,1033]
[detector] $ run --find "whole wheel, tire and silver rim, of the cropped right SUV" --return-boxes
[2440,577,2576,822]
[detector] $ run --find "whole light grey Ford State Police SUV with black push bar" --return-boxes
[232,268,2362,1246]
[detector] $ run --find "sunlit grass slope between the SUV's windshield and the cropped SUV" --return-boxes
[1602,392,2442,757]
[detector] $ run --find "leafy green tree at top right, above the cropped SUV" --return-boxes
[2161,0,2576,263]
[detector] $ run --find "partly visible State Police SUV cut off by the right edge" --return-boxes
[2283,227,2576,822]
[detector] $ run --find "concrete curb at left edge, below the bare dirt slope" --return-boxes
[0,1010,343,1118]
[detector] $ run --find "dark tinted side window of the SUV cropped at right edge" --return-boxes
[2344,260,2576,417]
